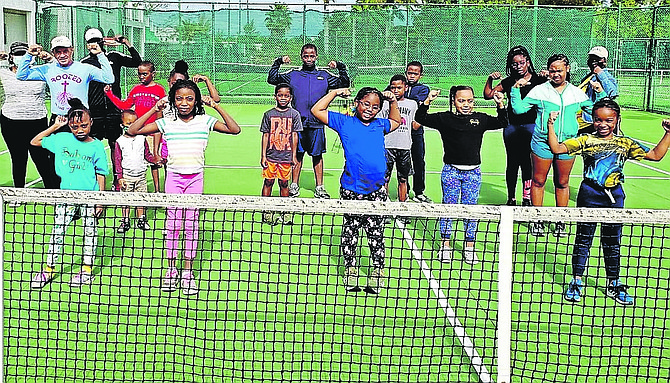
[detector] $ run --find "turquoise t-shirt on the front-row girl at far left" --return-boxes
[42,132,109,190]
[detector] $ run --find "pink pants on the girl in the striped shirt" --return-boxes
[165,170,204,260]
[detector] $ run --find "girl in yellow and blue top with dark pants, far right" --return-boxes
[547,98,670,305]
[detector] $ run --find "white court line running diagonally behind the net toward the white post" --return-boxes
[395,219,493,383]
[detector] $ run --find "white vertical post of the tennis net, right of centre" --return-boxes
[497,206,514,383]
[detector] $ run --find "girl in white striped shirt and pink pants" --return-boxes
[128,80,240,295]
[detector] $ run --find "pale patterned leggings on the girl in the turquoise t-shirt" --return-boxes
[47,204,98,267]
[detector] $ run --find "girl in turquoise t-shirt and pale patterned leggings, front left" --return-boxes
[30,98,109,289]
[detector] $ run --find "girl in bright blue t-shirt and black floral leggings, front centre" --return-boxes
[312,87,401,293]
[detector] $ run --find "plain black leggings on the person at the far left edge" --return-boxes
[0,114,60,189]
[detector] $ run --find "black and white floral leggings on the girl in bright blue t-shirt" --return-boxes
[340,187,388,268]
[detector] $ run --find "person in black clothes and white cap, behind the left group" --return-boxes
[81,28,142,186]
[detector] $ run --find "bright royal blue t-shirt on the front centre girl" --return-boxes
[328,112,391,194]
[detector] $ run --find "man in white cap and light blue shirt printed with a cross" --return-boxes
[16,36,114,124]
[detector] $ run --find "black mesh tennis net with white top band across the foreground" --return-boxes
[0,189,670,382]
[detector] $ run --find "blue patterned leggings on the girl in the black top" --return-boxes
[440,164,482,242]
